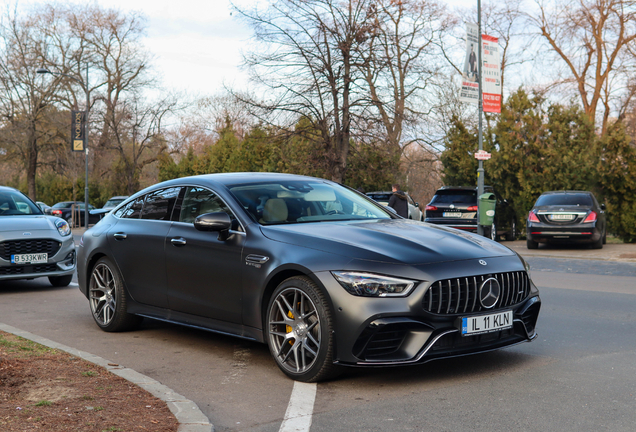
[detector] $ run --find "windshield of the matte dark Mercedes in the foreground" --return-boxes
[229,180,391,225]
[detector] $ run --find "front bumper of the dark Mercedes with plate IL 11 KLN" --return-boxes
[316,262,541,367]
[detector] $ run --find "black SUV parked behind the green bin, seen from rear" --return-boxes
[424,186,517,240]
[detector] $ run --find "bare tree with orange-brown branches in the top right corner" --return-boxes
[529,0,636,133]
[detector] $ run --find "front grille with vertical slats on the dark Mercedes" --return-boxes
[422,271,530,315]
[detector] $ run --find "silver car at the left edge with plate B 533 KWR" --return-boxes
[0,186,77,287]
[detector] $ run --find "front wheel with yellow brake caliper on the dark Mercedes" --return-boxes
[265,276,339,382]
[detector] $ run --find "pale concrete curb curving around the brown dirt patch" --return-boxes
[0,323,214,432]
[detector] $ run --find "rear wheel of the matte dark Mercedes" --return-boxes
[88,257,142,332]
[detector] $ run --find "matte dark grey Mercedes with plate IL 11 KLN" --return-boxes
[78,173,541,381]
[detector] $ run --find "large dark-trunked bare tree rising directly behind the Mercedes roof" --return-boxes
[237,0,373,182]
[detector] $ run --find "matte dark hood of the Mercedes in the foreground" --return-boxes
[261,219,514,265]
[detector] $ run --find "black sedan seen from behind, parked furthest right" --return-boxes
[526,191,607,249]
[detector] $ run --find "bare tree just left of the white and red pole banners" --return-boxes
[359,0,453,180]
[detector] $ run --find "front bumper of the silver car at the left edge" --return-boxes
[0,236,77,280]
